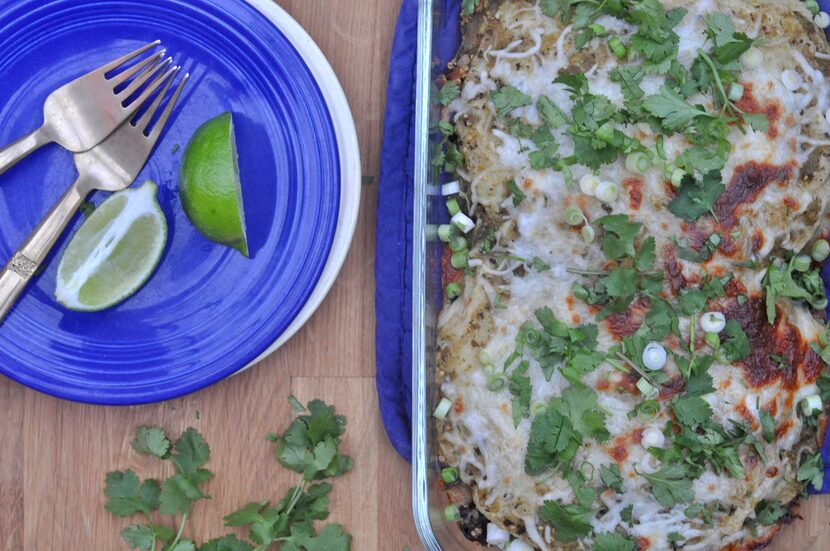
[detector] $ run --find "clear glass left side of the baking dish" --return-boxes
[412,0,483,551]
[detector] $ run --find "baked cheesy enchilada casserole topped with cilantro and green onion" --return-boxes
[434,0,830,551]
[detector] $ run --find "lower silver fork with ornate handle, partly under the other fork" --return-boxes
[0,67,190,323]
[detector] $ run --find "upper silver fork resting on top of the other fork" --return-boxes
[0,40,173,178]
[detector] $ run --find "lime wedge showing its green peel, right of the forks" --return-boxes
[179,113,248,257]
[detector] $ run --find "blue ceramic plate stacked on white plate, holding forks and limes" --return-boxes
[0,0,360,404]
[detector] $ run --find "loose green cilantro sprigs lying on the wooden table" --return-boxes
[104,399,352,551]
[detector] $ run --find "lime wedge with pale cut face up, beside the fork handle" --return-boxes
[55,181,167,312]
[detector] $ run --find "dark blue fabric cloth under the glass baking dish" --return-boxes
[375,0,830,493]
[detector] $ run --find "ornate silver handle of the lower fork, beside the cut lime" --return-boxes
[0,180,87,324]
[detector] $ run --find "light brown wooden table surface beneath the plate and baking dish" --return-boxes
[0,0,830,551]
